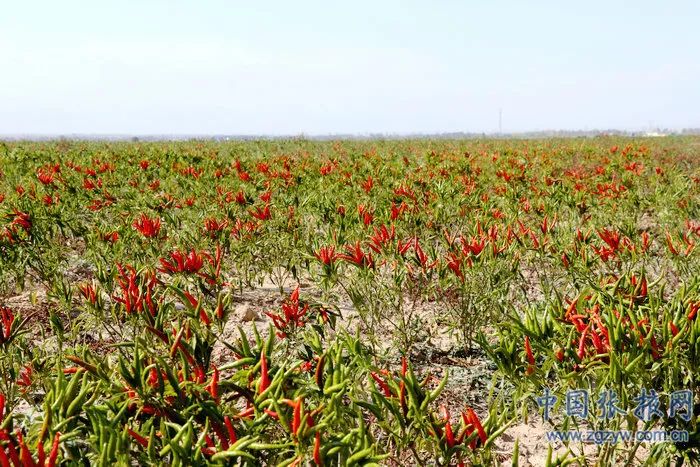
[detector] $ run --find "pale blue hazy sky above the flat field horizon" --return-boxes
[0,0,700,134]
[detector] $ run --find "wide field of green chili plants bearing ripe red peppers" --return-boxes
[0,137,700,466]
